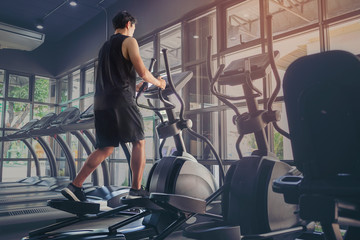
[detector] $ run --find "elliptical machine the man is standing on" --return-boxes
[25,50,222,240]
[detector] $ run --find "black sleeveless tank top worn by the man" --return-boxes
[94,34,136,110]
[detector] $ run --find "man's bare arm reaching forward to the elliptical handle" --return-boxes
[124,37,166,89]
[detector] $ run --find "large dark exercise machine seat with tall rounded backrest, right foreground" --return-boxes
[273,50,360,239]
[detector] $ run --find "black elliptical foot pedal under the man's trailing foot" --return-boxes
[47,199,100,215]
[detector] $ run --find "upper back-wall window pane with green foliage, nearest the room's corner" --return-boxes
[34,76,56,103]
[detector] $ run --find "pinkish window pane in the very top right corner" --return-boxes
[326,0,360,18]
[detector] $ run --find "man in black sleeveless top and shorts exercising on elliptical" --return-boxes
[61,11,166,201]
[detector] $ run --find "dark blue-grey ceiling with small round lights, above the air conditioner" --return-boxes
[0,0,119,42]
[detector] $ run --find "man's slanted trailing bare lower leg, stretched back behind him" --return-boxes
[73,147,114,187]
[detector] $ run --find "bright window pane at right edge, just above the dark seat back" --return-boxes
[329,19,360,54]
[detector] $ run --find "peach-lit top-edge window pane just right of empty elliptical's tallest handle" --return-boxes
[269,0,319,33]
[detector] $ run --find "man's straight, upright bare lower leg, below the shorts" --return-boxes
[130,140,146,189]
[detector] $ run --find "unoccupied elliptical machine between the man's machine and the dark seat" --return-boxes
[184,16,306,240]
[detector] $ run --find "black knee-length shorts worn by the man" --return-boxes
[95,105,144,148]
